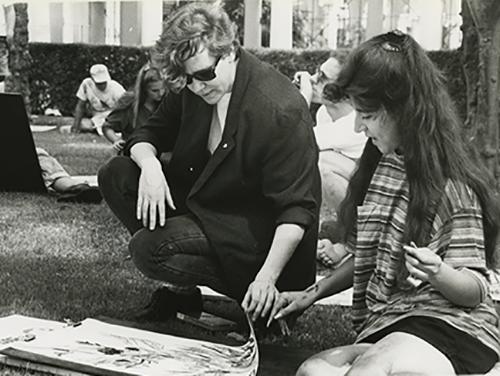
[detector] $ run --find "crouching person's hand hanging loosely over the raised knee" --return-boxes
[136,158,175,230]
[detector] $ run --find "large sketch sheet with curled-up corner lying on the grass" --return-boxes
[0,319,258,376]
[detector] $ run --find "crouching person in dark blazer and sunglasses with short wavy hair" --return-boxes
[99,3,321,330]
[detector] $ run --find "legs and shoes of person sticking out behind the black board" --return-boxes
[36,148,102,204]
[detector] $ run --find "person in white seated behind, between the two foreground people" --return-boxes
[294,57,366,266]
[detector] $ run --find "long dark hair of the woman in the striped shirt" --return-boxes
[336,31,499,266]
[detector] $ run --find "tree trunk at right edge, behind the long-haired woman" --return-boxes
[461,0,500,182]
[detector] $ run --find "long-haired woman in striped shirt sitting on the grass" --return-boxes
[273,31,500,376]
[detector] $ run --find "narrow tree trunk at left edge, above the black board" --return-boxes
[4,3,31,113]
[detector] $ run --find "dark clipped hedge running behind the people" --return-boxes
[29,43,466,115]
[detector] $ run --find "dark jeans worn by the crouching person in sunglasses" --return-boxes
[98,156,227,294]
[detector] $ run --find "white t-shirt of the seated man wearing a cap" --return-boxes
[76,77,125,115]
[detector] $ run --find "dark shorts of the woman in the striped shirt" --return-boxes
[362,316,498,375]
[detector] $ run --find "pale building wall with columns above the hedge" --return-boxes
[0,0,461,50]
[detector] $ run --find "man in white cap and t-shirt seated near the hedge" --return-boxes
[71,64,125,135]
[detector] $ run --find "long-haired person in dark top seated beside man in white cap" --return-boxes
[102,64,165,153]
